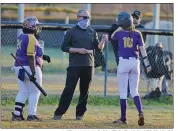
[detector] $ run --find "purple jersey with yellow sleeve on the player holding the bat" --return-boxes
[15,34,43,66]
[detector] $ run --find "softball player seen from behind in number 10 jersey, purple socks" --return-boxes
[111,12,151,126]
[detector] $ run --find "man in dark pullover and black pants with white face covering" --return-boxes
[53,9,108,120]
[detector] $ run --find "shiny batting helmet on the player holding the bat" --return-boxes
[23,16,41,32]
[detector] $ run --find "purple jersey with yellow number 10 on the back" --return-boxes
[111,28,144,57]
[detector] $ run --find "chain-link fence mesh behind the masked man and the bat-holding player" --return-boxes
[1,24,172,99]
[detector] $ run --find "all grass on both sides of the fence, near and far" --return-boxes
[0,47,174,129]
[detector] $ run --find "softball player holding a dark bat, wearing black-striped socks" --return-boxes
[12,16,43,121]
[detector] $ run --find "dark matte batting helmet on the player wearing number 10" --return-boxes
[117,12,133,29]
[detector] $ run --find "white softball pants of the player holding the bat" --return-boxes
[13,66,42,115]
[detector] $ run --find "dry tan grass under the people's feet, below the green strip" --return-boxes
[2,105,173,129]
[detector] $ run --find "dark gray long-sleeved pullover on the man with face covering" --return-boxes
[61,25,101,66]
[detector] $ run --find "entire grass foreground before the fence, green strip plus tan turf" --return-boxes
[1,95,174,129]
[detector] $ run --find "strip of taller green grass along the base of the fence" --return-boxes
[1,95,173,106]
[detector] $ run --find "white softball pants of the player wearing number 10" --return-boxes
[117,57,140,99]
